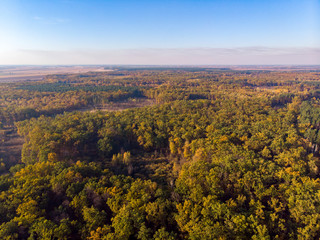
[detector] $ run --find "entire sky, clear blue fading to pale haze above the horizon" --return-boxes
[0,0,320,65]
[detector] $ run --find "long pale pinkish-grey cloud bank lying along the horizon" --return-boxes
[0,47,320,65]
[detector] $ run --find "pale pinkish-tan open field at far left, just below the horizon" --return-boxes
[0,66,110,82]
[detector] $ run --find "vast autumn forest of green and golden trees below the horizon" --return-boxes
[0,67,320,240]
